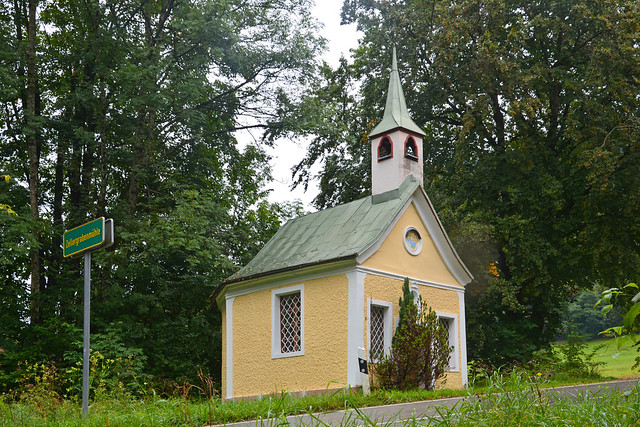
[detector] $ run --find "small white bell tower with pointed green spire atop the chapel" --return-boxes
[369,47,425,195]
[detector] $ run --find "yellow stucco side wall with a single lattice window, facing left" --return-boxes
[230,274,348,397]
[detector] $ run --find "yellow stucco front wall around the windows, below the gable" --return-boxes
[364,274,463,389]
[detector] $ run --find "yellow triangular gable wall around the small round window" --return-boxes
[362,203,460,286]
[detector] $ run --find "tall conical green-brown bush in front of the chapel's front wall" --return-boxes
[372,279,452,390]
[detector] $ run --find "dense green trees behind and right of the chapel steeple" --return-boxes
[278,0,640,365]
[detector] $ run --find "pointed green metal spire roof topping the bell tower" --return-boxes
[369,47,425,137]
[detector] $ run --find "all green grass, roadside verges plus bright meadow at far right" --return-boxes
[0,339,640,426]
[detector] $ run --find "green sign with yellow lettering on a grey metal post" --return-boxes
[62,217,114,418]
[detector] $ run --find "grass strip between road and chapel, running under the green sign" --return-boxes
[0,390,467,426]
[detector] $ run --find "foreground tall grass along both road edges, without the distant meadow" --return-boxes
[0,371,640,426]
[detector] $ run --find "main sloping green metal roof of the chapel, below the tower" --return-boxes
[222,175,419,286]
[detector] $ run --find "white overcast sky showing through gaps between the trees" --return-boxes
[260,0,361,211]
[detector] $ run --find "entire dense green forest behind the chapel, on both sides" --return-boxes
[0,0,640,400]
